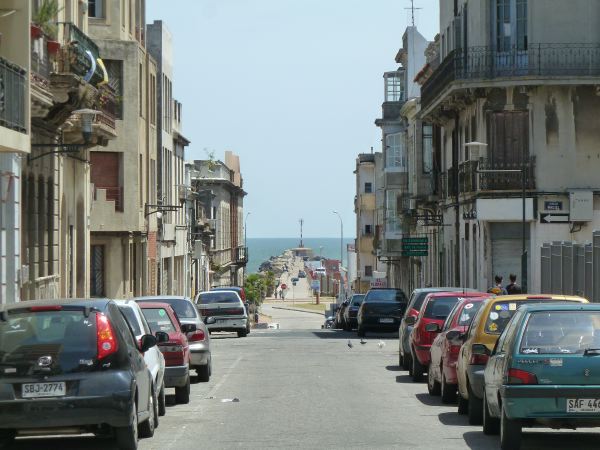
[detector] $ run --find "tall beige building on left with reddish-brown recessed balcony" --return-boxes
[89,0,159,298]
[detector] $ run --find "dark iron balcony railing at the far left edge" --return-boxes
[0,57,29,133]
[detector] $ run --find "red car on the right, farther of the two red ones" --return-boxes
[406,292,489,381]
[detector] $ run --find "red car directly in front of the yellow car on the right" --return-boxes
[427,295,489,403]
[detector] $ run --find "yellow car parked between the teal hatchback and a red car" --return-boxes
[456,294,587,425]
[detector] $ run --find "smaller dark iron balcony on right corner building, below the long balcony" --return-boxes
[459,156,536,193]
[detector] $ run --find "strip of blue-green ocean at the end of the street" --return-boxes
[246,238,354,273]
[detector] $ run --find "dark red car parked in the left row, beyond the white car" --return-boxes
[138,302,196,403]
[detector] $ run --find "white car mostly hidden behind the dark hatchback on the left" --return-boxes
[115,300,167,418]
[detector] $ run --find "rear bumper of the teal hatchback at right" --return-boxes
[500,385,600,420]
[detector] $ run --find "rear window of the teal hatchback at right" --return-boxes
[520,311,600,355]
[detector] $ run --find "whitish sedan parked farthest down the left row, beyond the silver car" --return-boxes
[196,291,248,337]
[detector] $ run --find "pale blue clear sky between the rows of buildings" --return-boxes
[146,0,439,238]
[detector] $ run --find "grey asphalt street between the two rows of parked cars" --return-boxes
[8,308,600,450]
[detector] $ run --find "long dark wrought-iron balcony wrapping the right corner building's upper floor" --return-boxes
[421,44,600,110]
